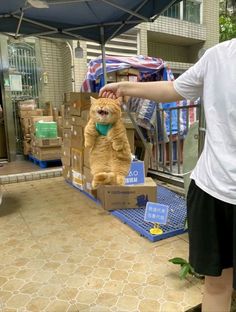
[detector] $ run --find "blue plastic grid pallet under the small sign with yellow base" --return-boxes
[111,186,187,242]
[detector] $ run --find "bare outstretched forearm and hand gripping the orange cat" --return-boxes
[99,81,183,103]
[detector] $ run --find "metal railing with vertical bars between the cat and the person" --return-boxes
[149,104,201,177]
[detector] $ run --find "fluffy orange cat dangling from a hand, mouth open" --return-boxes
[84,97,131,189]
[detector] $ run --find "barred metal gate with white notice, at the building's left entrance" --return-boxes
[8,42,39,154]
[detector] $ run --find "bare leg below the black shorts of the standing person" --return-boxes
[202,268,233,312]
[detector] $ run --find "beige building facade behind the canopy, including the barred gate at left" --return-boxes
[0,0,219,160]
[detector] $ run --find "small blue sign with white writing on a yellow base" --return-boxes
[144,202,169,224]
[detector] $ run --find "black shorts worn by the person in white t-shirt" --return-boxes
[187,180,236,289]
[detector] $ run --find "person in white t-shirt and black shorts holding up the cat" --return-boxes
[100,39,236,312]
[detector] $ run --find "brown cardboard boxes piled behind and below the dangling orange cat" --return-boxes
[62,92,156,210]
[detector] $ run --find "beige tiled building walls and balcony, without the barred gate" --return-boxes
[37,0,219,105]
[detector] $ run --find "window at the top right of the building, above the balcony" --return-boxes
[163,0,202,24]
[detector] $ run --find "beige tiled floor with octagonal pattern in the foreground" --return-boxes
[0,177,202,312]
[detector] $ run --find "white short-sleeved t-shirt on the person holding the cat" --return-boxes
[174,39,236,205]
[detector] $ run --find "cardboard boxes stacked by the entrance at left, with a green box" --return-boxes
[19,100,62,160]
